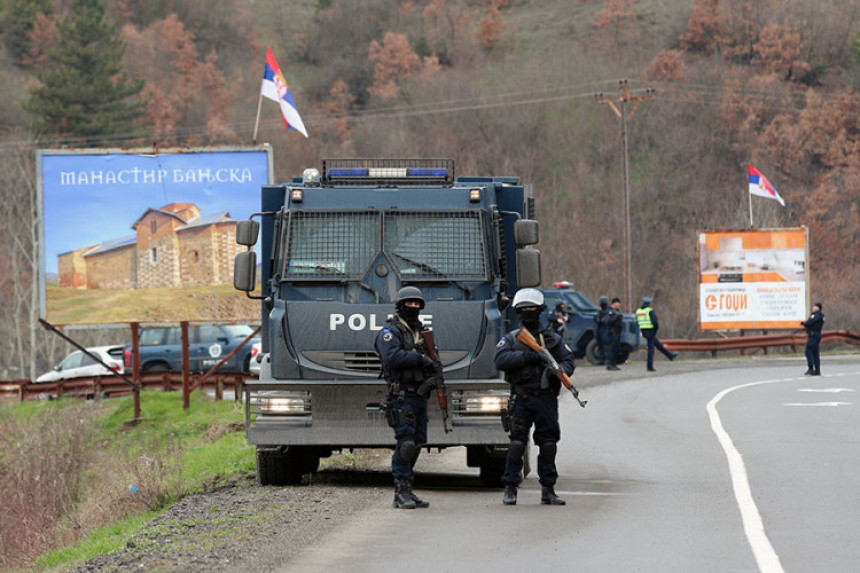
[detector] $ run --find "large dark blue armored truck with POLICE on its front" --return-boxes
[234,159,540,485]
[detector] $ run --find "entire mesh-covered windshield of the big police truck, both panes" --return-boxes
[282,211,488,281]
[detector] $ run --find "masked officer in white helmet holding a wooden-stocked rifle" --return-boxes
[495,288,574,505]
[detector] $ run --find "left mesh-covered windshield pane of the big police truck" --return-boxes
[284,211,380,278]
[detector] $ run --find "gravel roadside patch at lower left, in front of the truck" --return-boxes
[74,473,391,573]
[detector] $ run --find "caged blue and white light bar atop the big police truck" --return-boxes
[322,159,454,186]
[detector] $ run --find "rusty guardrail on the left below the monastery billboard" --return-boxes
[0,372,256,402]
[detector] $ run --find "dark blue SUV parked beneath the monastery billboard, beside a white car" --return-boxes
[123,324,260,373]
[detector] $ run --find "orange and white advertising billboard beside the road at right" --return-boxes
[699,227,809,330]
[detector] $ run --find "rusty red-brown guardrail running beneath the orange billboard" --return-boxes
[660,330,860,356]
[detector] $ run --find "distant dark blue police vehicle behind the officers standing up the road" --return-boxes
[541,281,640,364]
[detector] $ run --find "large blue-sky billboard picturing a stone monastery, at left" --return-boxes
[37,145,273,325]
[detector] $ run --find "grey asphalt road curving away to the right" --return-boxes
[283,356,860,573]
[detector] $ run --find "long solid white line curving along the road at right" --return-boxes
[706,378,796,573]
